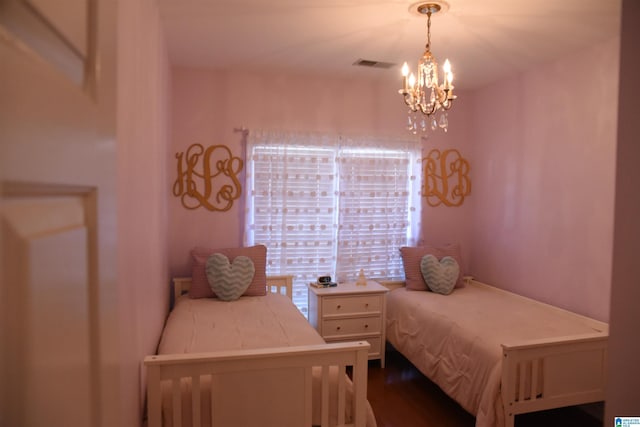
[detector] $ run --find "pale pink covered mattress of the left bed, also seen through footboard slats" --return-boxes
[158,293,376,427]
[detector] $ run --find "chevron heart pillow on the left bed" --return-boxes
[205,253,256,301]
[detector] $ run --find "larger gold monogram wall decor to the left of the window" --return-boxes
[173,144,244,212]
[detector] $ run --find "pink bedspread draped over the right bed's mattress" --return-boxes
[387,282,600,427]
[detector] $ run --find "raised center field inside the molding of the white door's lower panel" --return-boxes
[28,227,90,427]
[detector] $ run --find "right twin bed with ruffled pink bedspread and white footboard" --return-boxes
[386,280,608,427]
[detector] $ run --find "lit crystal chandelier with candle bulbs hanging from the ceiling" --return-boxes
[398,3,456,134]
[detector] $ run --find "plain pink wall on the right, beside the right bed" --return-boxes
[470,39,619,321]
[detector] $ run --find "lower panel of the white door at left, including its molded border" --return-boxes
[0,187,100,427]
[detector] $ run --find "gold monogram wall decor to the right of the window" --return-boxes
[422,149,471,206]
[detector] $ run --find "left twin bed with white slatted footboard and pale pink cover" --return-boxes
[144,276,376,427]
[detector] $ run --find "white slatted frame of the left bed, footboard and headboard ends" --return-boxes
[144,276,369,427]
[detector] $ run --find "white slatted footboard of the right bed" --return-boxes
[501,333,607,427]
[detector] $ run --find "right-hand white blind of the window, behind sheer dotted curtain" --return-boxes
[336,148,415,279]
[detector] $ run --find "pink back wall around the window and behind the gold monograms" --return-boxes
[169,68,476,275]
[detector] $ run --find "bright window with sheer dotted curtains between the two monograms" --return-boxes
[245,131,420,315]
